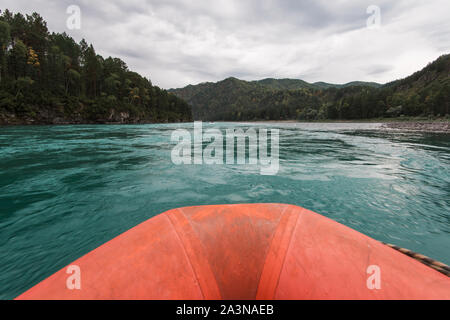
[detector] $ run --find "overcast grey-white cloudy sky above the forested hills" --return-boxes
[0,0,450,88]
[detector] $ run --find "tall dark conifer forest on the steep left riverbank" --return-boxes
[0,10,192,124]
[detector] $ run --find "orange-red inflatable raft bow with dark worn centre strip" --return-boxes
[18,204,450,300]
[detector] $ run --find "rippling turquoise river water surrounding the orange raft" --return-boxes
[0,123,450,299]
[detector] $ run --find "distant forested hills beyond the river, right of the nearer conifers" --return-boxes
[171,54,450,121]
